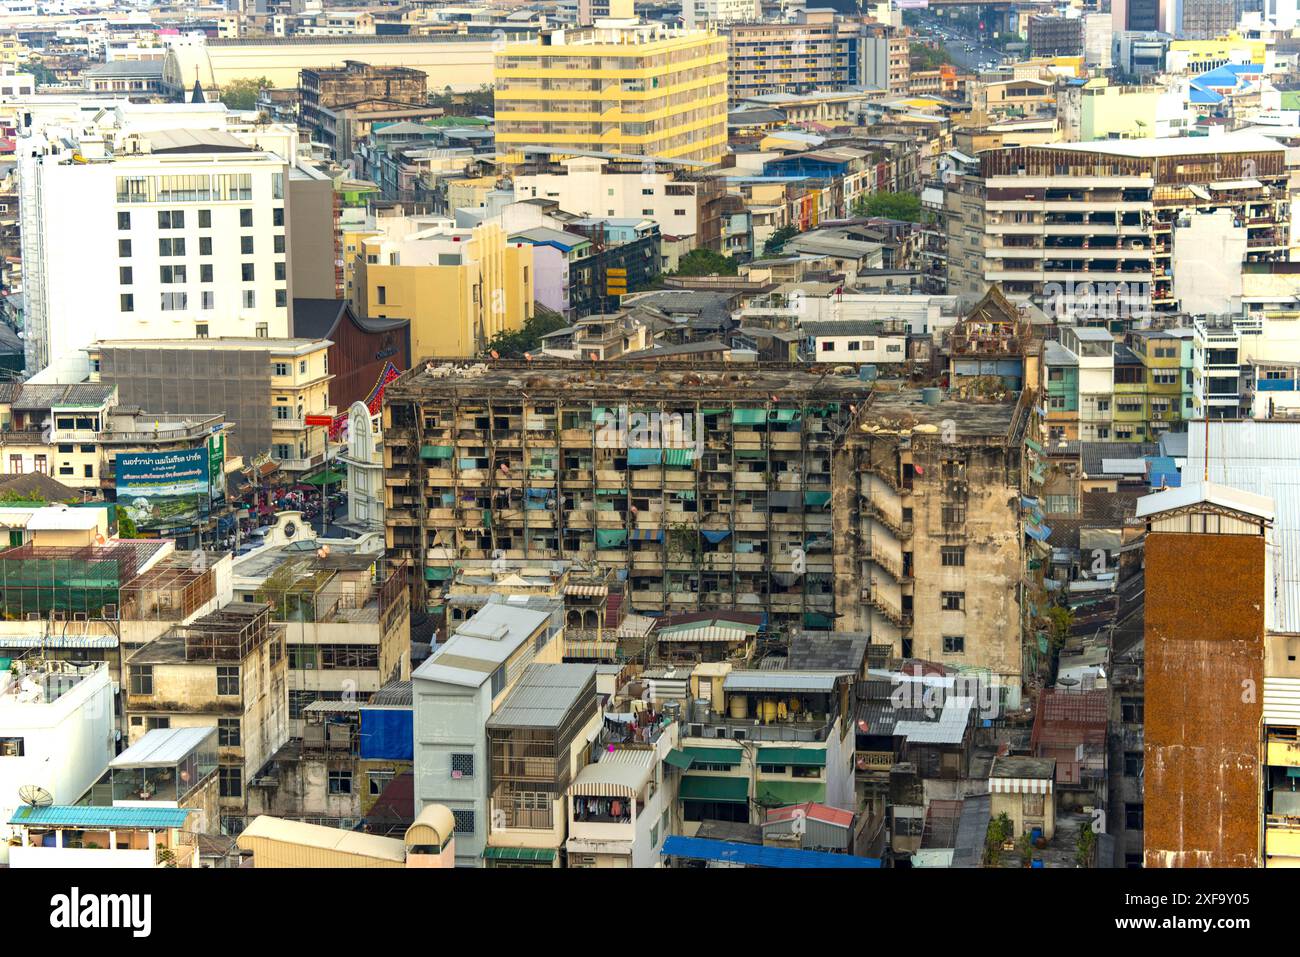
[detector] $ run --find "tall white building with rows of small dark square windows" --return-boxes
[18,104,296,373]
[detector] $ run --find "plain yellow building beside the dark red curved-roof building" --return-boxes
[352,217,533,361]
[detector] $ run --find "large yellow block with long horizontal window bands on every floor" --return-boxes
[494,20,727,163]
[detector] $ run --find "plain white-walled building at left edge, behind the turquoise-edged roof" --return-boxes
[0,661,114,863]
